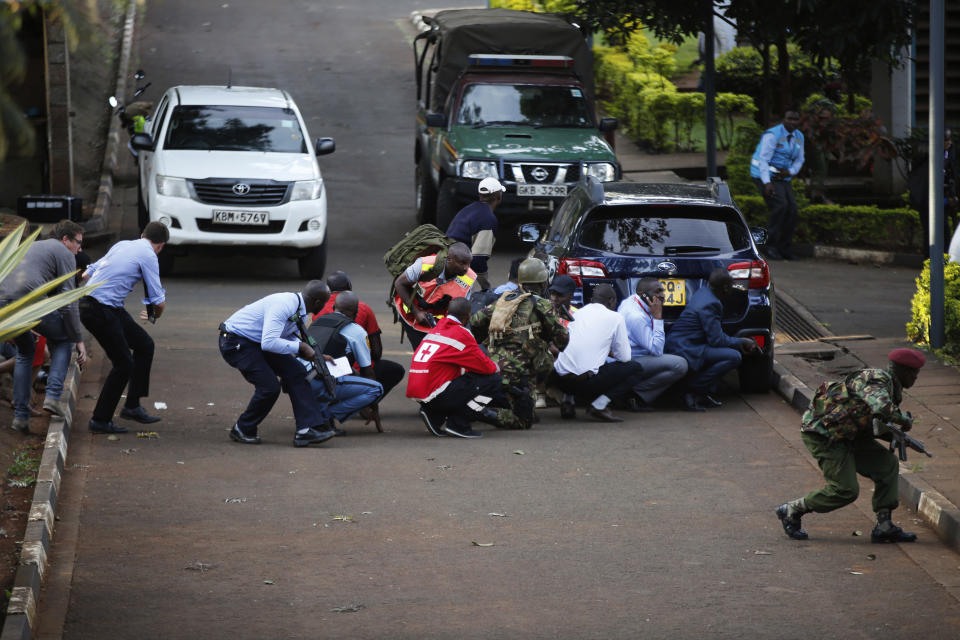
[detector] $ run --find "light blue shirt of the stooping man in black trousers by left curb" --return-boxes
[87,238,166,307]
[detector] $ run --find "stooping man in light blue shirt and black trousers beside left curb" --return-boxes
[80,222,170,433]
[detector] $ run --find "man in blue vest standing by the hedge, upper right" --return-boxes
[750,109,803,260]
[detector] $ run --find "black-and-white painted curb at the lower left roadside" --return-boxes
[0,360,80,640]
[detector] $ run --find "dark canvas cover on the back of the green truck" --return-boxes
[425,9,593,109]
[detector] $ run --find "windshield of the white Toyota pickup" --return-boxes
[164,106,307,153]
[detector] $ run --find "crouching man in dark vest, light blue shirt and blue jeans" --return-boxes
[307,291,383,435]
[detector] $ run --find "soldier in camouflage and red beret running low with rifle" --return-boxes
[776,349,925,542]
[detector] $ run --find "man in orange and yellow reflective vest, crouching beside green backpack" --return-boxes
[393,242,477,349]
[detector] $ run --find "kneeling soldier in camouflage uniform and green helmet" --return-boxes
[470,258,570,429]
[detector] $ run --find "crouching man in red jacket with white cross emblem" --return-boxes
[407,297,500,438]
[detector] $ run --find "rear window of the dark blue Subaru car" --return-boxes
[579,205,750,256]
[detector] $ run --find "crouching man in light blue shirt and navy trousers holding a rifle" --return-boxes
[219,280,334,447]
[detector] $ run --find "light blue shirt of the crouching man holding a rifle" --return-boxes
[223,293,307,355]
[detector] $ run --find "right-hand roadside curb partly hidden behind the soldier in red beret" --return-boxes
[772,352,960,552]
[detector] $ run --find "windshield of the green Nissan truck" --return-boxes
[457,84,593,128]
